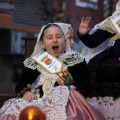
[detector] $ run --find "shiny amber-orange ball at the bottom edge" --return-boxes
[19,106,46,120]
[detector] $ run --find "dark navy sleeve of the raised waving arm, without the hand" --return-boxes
[77,29,114,48]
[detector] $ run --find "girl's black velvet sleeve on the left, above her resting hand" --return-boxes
[15,66,40,94]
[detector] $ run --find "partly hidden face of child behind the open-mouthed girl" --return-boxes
[66,29,74,48]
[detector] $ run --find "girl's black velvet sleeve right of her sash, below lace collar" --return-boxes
[68,61,94,97]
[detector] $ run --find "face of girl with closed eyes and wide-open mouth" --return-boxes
[40,26,65,57]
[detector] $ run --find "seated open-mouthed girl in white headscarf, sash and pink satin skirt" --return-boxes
[0,24,104,120]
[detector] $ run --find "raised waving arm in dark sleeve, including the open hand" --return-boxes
[77,17,114,48]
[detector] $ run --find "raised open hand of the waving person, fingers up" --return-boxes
[79,17,91,35]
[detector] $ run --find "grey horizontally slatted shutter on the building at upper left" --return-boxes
[12,0,53,28]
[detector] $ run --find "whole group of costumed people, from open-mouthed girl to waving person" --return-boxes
[0,1,120,120]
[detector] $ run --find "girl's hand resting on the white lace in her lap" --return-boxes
[23,91,37,102]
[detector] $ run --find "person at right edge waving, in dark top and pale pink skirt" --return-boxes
[77,1,120,120]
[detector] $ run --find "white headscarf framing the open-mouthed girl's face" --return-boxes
[31,23,71,57]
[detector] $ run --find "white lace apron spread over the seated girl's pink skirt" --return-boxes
[1,86,69,120]
